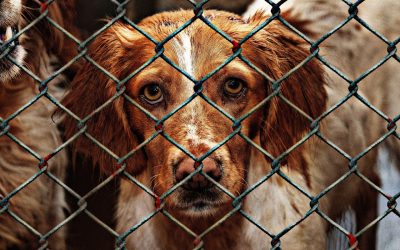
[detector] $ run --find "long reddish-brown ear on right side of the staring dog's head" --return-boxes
[248,13,327,161]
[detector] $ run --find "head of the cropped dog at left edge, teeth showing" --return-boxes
[0,0,77,82]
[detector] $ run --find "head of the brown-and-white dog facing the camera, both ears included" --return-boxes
[64,11,326,216]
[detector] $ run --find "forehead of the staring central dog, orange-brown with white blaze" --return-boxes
[140,10,245,78]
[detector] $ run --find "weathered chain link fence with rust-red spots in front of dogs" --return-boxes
[0,0,400,249]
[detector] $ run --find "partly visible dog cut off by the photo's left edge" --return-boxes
[0,0,78,249]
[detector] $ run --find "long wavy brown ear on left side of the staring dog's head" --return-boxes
[63,24,146,174]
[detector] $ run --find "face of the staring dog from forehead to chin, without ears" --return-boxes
[123,20,268,214]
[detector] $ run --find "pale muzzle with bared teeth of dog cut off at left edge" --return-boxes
[0,0,25,82]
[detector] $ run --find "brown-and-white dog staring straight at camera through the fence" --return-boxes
[63,1,395,249]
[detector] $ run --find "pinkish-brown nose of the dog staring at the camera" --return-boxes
[175,158,222,191]
